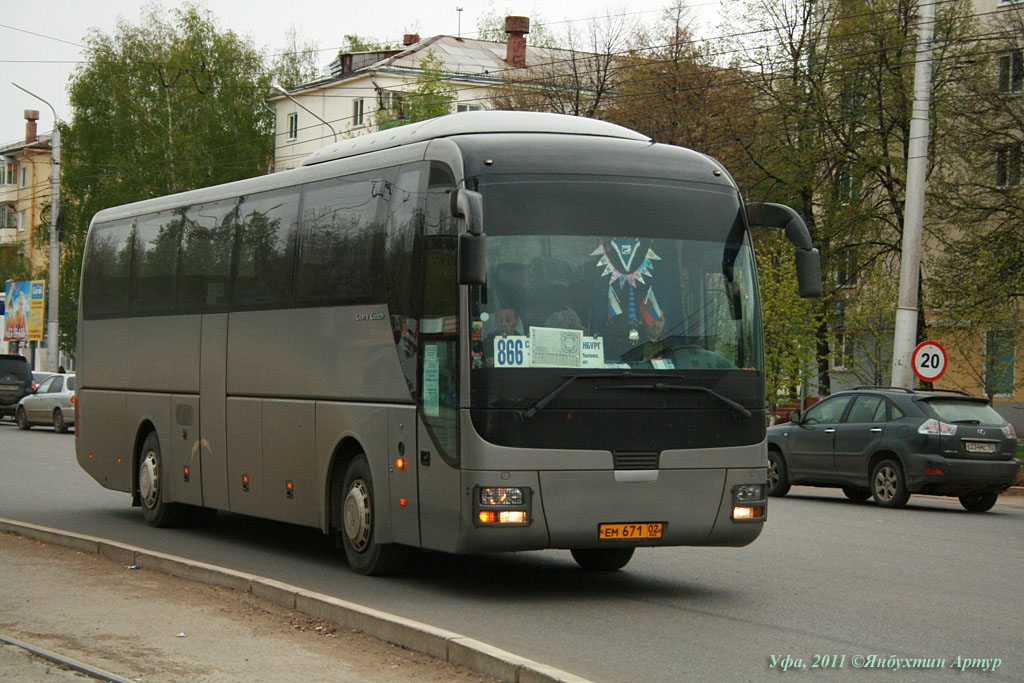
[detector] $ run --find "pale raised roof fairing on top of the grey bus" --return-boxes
[302,112,650,166]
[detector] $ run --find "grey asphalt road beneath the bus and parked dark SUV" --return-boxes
[0,420,1024,681]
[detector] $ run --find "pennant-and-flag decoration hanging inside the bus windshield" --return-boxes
[591,238,663,344]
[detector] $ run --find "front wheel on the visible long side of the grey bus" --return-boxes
[340,454,409,577]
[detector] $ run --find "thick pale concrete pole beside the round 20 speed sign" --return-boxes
[892,0,935,388]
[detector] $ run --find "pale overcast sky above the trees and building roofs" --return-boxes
[0,0,719,143]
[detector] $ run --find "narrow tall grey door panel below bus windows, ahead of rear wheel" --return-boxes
[193,313,229,510]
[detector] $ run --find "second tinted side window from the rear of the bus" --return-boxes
[131,211,181,313]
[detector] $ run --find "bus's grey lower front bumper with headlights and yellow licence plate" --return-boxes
[456,468,767,553]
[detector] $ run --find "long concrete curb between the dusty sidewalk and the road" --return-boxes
[0,518,588,683]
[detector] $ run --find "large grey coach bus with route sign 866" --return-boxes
[76,112,820,574]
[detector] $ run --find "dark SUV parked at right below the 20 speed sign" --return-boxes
[768,387,1020,512]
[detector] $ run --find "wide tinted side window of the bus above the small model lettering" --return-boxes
[295,174,391,304]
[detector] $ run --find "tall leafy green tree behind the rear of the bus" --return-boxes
[60,4,273,352]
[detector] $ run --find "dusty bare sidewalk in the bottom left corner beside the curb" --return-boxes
[0,532,496,683]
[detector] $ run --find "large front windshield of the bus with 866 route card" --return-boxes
[471,179,763,375]
